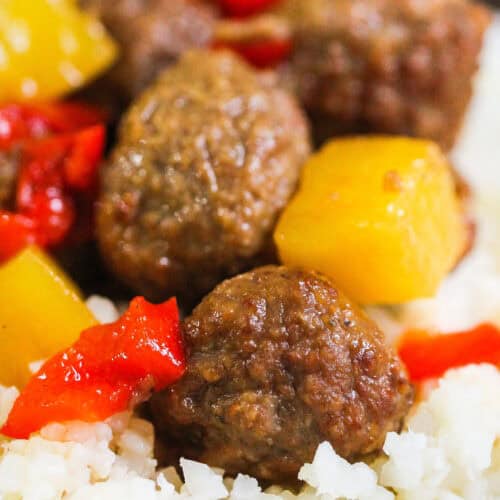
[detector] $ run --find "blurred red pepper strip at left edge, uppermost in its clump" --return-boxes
[0,102,106,150]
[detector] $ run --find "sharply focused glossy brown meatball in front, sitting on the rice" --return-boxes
[152,266,413,482]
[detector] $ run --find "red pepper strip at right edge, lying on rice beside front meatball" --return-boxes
[398,324,500,382]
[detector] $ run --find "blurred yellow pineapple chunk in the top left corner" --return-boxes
[0,0,118,102]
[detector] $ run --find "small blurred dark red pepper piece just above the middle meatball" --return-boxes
[214,39,292,68]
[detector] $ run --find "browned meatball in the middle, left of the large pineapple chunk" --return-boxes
[97,51,310,303]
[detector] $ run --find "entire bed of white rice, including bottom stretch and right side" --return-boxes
[0,13,500,500]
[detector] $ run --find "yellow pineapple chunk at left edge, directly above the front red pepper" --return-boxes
[0,247,96,388]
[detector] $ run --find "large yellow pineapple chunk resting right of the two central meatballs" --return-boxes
[274,137,467,304]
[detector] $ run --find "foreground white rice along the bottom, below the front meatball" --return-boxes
[0,365,500,500]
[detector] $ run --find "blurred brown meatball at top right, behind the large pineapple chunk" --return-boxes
[278,0,489,149]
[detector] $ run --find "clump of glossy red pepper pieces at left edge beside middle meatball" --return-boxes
[0,103,106,262]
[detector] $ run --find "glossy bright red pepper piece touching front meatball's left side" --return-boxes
[0,297,185,439]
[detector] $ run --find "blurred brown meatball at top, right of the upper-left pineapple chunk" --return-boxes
[80,0,215,100]
